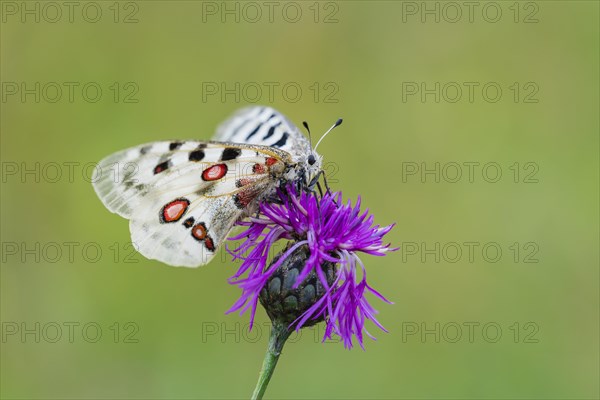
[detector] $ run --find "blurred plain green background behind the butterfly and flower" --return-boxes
[0,1,599,399]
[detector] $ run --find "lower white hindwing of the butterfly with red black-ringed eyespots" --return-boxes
[130,170,269,267]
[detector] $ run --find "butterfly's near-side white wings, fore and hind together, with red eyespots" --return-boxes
[94,141,291,267]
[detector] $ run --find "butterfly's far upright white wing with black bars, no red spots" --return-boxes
[213,106,311,162]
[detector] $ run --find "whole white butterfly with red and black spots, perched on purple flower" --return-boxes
[93,106,342,267]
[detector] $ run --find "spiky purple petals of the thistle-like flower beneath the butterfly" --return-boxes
[228,185,397,348]
